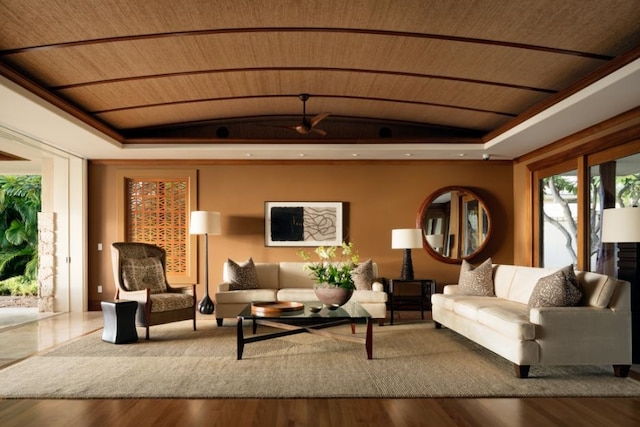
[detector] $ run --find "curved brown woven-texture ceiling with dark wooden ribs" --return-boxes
[0,0,640,144]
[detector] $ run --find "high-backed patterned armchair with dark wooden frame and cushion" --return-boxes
[111,242,196,339]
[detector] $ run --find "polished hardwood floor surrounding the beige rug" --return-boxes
[0,309,640,427]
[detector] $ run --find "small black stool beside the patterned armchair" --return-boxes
[100,299,138,344]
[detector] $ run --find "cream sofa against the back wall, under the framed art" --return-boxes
[215,262,387,326]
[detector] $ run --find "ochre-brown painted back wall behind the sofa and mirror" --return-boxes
[89,161,514,309]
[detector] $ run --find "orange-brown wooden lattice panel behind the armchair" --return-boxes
[126,178,189,275]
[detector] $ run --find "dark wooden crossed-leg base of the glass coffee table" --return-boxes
[237,316,373,360]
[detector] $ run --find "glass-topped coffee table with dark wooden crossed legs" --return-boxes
[237,301,373,360]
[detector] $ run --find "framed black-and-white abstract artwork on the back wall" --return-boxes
[264,202,343,247]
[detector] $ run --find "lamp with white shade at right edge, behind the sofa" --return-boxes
[600,208,640,364]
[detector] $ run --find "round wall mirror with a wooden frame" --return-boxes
[416,187,491,264]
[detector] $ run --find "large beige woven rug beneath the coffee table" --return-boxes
[0,320,640,399]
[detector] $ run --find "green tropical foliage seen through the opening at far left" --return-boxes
[0,175,42,295]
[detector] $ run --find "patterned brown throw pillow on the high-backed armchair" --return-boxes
[122,257,167,294]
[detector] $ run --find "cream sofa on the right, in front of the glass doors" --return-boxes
[431,265,631,378]
